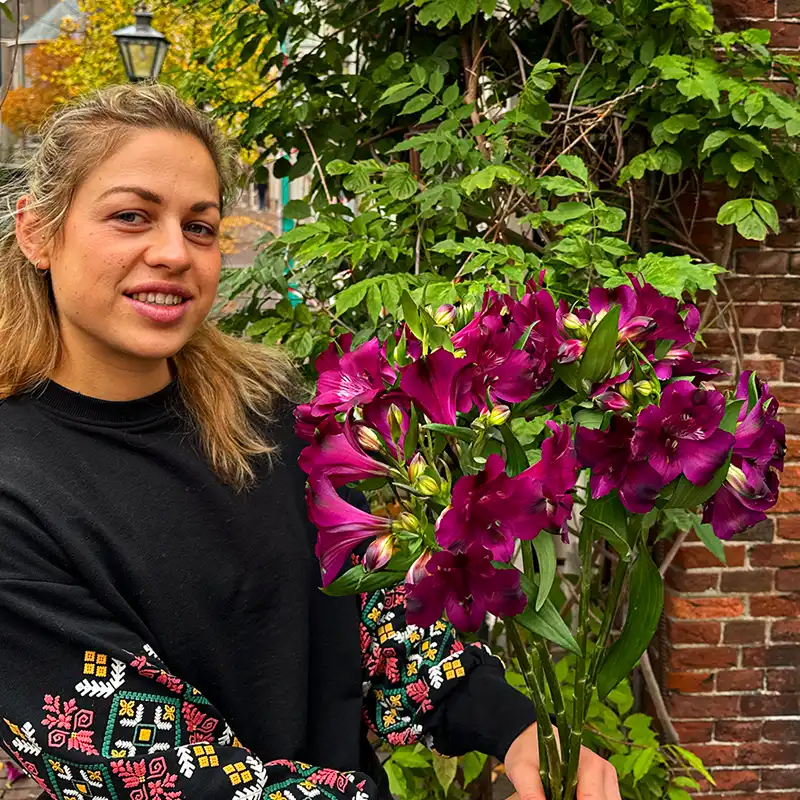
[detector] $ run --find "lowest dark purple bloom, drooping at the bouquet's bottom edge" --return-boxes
[406,544,527,631]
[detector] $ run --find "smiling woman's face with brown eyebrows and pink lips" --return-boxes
[41,131,221,378]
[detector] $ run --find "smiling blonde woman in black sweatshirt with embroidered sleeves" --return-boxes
[0,85,619,800]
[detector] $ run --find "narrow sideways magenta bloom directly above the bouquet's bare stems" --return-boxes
[514,422,578,541]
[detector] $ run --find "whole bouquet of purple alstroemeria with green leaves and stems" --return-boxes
[297,276,784,800]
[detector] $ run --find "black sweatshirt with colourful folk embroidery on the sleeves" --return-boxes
[0,382,534,800]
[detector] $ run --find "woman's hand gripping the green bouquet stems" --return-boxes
[505,723,621,800]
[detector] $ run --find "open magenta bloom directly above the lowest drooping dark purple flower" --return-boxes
[436,453,526,561]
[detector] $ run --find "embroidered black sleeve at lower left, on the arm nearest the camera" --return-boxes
[0,495,375,800]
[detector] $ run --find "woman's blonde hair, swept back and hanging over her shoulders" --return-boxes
[0,83,298,490]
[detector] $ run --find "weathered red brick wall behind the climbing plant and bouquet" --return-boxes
[663,6,800,800]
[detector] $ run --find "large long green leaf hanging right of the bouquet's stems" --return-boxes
[597,547,664,699]
